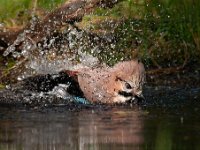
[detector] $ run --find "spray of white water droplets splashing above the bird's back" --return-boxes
[3,12,120,80]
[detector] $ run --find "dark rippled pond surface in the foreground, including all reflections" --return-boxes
[0,86,200,150]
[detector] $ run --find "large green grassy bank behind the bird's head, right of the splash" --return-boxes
[86,0,200,68]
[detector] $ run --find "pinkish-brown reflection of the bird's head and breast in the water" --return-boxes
[79,110,143,149]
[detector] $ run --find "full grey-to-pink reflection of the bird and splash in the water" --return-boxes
[0,109,143,150]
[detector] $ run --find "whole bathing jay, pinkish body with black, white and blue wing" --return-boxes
[0,60,145,106]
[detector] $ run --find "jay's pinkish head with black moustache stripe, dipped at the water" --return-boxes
[111,60,145,102]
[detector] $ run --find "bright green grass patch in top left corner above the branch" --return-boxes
[0,0,65,27]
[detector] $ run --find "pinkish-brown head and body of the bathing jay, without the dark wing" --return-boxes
[65,60,145,104]
